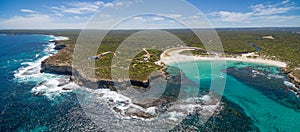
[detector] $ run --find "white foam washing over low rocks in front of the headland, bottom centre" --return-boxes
[79,87,220,123]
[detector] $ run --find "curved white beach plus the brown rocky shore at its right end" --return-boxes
[156,47,300,97]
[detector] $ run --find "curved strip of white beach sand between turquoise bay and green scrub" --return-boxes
[157,47,287,67]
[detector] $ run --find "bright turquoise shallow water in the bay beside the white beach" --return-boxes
[173,61,300,131]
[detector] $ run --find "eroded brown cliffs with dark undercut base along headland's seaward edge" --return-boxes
[41,43,149,91]
